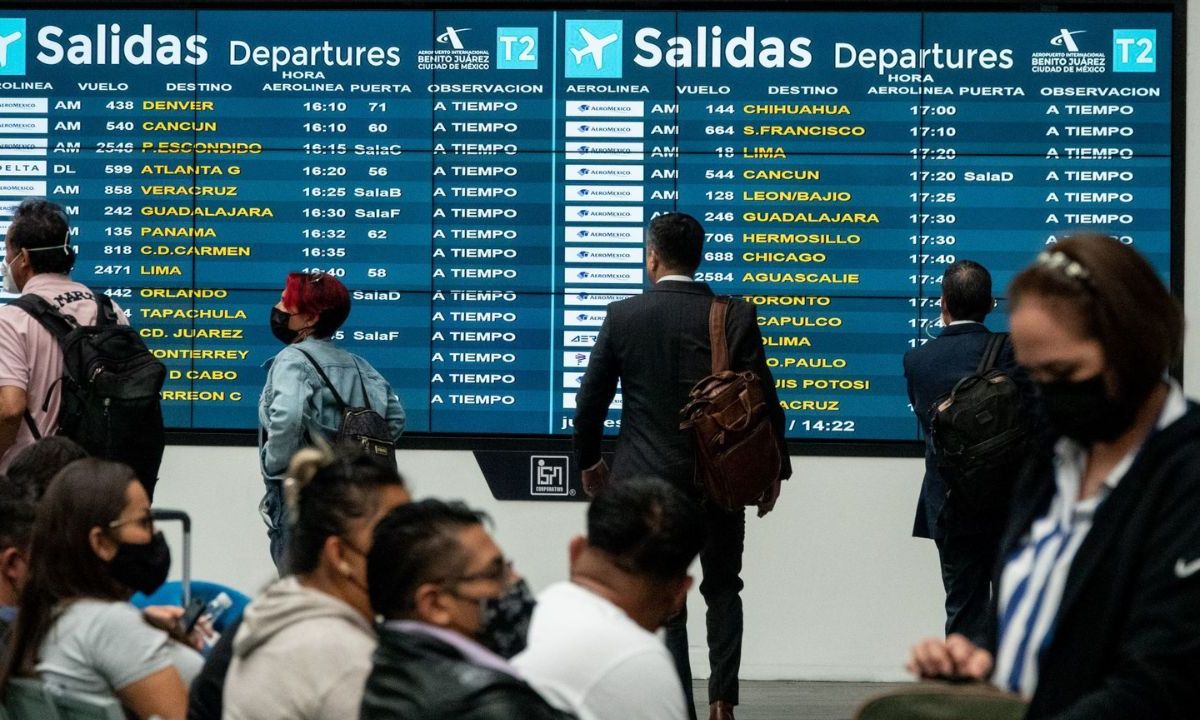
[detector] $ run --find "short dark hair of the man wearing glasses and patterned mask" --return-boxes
[367,499,487,618]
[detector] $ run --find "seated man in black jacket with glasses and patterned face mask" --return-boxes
[360,500,571,720]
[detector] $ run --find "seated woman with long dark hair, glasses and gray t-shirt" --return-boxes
[0,458,202,720]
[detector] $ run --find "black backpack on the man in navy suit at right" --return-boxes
[929,332,1033,512]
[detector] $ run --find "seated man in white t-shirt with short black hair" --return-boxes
[512,479,704,720]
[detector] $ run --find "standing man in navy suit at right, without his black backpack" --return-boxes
[904,260,1028,641]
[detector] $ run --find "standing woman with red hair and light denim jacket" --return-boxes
[258,272,404,570]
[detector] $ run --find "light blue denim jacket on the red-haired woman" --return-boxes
[258,337,404,481]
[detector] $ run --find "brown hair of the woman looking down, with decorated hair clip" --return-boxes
[1008,233,1183,403]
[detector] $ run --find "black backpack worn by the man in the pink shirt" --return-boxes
[12,293,167,499]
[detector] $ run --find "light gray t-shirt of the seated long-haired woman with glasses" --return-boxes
[37,600,204,697]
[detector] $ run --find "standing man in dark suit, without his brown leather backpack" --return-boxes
[575,212,792,720]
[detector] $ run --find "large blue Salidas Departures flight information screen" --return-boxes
[0,6,1174,440]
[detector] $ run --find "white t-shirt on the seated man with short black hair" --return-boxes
[512,582,688,720]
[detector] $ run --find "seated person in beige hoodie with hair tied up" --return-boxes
[223,444,408,720]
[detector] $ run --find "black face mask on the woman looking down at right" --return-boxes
[1038,374,1141,445]
